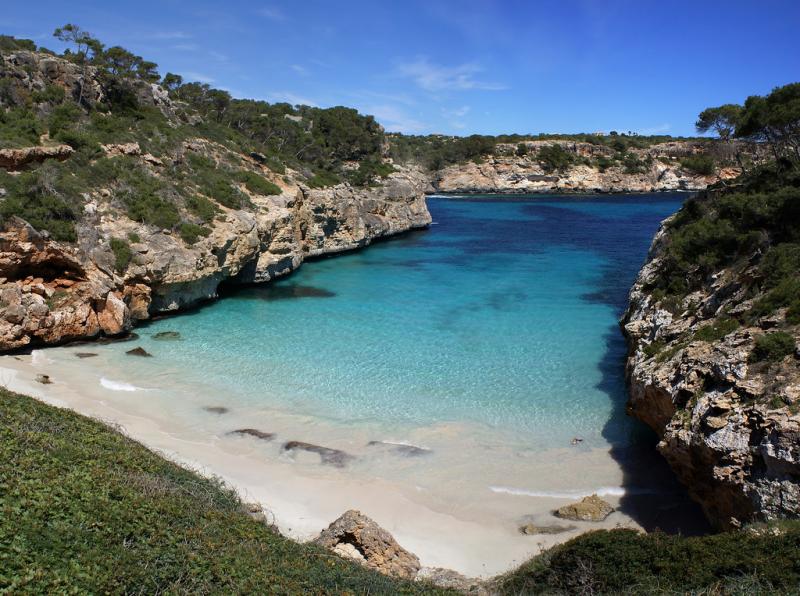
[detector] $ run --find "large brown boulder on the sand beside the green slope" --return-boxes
[314,509,420,579]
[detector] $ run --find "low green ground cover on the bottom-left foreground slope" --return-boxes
[0,390,444,594]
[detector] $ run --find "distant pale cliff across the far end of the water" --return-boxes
[432,140,740,193]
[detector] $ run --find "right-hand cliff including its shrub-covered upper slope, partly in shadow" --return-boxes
[622,179,800,528]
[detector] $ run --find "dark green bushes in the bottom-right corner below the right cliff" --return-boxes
[498,522,800,594]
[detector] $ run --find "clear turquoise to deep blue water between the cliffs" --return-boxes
[122,194,685,446]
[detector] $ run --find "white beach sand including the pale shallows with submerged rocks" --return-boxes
[0,346,635,577]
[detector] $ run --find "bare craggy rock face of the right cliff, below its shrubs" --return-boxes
[622,217,800,528]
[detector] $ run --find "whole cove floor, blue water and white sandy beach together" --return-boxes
[2,193,704,576]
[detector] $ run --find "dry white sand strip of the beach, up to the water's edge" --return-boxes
[0,348,660,578]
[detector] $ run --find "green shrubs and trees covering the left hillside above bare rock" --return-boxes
[0,25,393,244]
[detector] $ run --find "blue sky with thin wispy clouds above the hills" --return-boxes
[0,0,800,135]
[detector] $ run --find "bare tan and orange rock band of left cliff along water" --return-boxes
[0,162,430,350]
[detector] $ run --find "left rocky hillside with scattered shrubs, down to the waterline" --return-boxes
[0,51,430,350]
